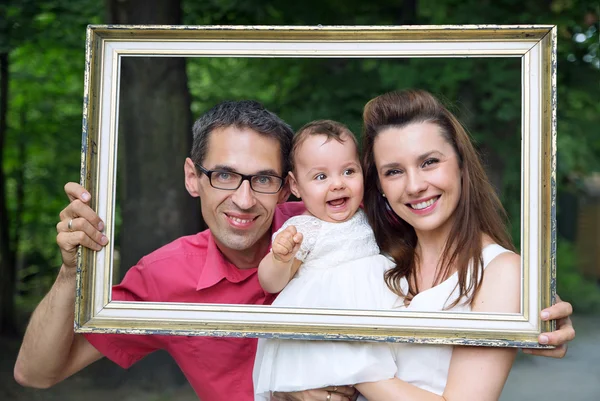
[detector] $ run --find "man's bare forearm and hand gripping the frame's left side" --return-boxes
[14,183,108,388]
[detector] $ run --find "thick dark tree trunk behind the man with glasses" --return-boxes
[108,0,201,277]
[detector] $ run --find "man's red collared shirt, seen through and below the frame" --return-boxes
[85,202,305,401]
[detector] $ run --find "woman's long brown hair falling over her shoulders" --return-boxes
[363,90,514,308]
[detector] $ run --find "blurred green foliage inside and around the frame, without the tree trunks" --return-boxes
[0,0,600,310]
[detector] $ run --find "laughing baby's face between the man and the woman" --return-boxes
[290,135,364,223]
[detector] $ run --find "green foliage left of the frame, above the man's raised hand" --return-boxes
[0,0,102,298]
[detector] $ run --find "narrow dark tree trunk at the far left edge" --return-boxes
[0,52,16,334]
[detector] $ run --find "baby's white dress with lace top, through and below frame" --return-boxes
[253,210,397,400]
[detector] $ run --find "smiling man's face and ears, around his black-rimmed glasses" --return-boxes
[185,126,288,252]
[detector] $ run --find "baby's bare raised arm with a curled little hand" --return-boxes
[258,226,302,293]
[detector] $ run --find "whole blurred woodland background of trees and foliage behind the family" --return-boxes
[0,0,600,401]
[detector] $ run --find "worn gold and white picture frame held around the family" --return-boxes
[75,25,556,347]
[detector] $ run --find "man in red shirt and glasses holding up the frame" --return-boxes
[15,101,574,401]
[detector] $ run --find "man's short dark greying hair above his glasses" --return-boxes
[191,100,294,177]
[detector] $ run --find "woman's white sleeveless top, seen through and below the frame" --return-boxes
[358,244,511,401]
